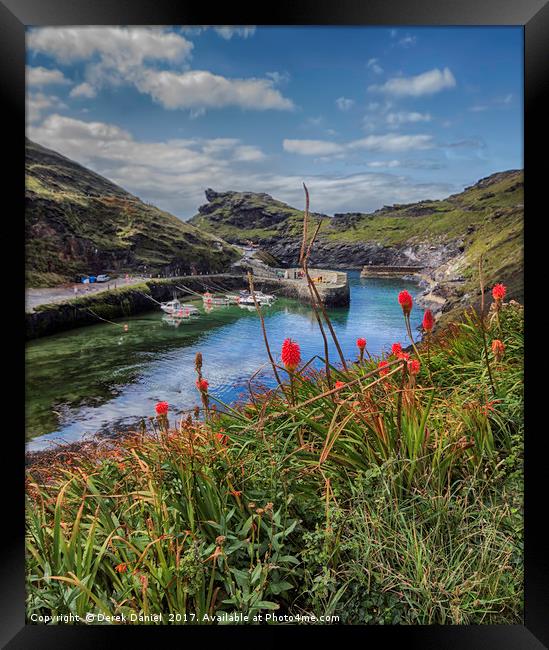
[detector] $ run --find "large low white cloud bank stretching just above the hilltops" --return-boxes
[27,115,454,217]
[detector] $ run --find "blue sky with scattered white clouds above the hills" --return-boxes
[27,26,523,218]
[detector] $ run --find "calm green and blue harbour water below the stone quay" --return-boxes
[26,272,423,449]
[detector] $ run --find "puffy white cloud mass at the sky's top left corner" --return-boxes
[28,26,293,111]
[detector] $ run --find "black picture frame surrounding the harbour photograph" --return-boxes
[6,0,549,650]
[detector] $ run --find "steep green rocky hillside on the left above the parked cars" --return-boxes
[25,140,239,286]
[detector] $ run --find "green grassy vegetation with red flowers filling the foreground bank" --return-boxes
[26,302,523,624]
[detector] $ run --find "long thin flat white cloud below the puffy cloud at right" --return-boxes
[282,133,434,156]
